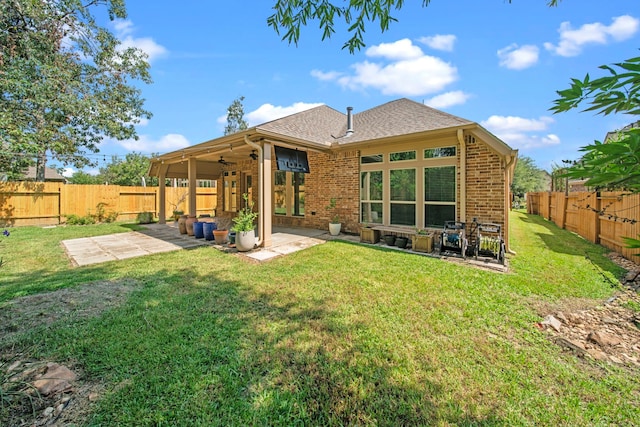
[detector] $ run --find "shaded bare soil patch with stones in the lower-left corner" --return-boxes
[0,279,140,426]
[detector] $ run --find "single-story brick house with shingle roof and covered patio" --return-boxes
[150,98,517,252]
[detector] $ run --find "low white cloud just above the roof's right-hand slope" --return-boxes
[480,116,560,149]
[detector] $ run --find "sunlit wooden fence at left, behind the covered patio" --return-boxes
[0,182,217,226]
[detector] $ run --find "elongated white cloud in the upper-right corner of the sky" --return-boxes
[544,15,640,56]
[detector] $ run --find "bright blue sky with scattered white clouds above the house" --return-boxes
[67,0,640,176]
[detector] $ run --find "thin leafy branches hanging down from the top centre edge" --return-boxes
[267,0,560,53]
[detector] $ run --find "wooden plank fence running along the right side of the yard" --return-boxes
[527,192,640,262]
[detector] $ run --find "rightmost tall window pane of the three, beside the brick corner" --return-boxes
[424,166,456,227]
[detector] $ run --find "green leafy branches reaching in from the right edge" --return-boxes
[551,53,640,254]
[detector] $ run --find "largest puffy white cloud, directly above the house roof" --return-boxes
[311,39,458,96]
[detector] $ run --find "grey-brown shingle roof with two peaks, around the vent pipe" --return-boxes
[256,98,473,145]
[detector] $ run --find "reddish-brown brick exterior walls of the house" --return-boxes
[216,135,506,236]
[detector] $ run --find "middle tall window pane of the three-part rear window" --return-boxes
[389,168,416,226]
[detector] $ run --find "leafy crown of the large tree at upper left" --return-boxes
[0,0,151,181]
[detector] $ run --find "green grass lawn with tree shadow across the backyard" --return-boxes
[0,212,640,426]
